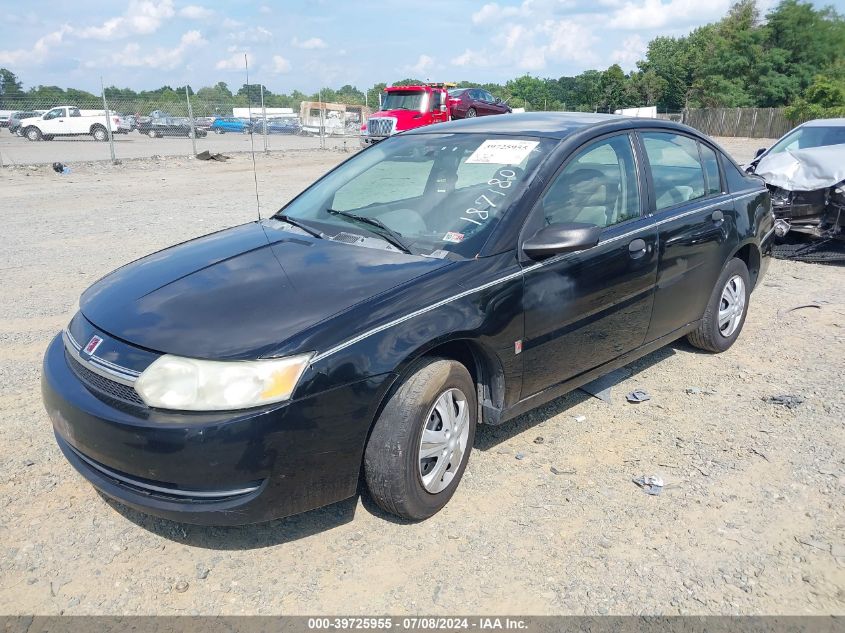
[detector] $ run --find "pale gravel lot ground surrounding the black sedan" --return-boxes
[0,138,845,615]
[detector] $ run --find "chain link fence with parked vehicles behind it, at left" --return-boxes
[0,91,369,165]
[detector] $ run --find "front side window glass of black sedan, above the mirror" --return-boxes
[540,134,640,227]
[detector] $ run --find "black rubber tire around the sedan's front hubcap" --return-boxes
[364,358,478,521]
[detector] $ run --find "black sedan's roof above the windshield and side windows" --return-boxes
[404,112,702,139]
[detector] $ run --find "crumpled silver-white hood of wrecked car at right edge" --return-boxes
[754,145,845,191]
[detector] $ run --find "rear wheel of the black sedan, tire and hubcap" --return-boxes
[687,258,751,353]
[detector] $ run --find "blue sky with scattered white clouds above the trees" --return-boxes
[0,0,845,93]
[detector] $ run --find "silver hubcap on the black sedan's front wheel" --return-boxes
[418,389,469,494]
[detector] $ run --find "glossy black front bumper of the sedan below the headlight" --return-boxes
[41,336,392,525]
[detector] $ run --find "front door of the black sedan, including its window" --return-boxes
[522,133,657,398]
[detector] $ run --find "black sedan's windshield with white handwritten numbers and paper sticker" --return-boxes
[279,134,555,257]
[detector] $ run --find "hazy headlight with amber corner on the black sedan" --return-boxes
[135,354,311,411]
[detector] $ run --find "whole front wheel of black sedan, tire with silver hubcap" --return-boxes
[364,358,478,520]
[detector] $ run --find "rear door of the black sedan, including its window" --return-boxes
[640,130,736,341]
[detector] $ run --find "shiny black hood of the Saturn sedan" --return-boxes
[80,222,449,359]
